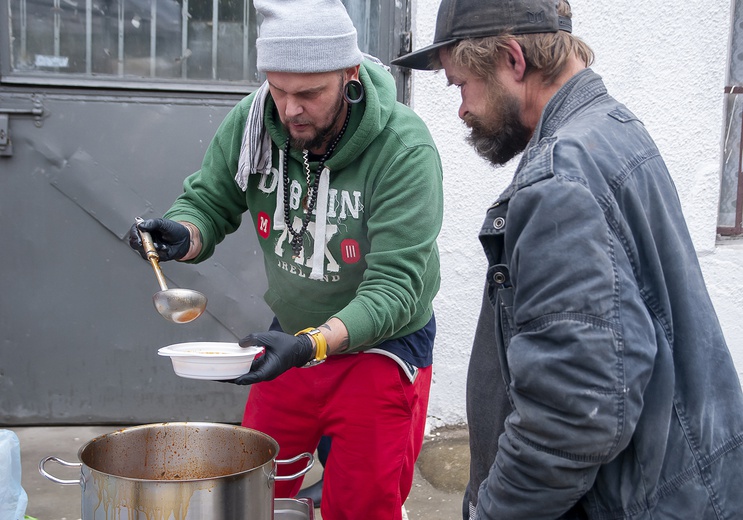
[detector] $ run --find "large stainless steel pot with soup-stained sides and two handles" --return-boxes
[39,422,314,520]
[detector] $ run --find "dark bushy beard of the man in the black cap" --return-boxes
[464,96,532,166]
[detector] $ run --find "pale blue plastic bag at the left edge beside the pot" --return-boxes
[0,430,28,520]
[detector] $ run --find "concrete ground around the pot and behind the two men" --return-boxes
[8,425,469,520]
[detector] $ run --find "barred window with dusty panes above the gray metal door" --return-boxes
[0,0,404,90]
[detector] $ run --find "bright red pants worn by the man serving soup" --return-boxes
[242,353,431,520]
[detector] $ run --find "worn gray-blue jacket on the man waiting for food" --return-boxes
[468,69,743,520]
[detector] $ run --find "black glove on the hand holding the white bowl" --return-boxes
[231,331,315,385]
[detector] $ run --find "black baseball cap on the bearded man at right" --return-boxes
[391,0,573,70]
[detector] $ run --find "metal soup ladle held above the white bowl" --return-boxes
[135,217,206,323]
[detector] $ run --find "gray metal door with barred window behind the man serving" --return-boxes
[0,0,404,425]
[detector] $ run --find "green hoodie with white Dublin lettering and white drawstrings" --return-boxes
[165,61,443,351]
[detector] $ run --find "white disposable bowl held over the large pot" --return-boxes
[157,341,263,380]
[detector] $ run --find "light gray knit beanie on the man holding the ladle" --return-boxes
[253,0,363,72]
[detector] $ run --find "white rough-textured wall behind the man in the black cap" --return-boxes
[412,0,743,428]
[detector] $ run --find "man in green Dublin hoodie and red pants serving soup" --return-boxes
[130,0,443,520]
